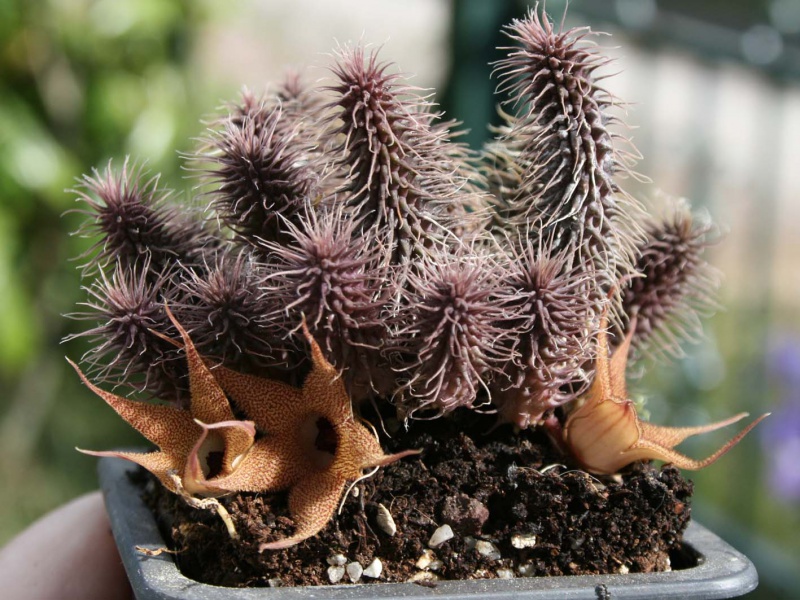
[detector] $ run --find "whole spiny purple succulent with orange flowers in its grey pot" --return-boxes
[69,5,763,598]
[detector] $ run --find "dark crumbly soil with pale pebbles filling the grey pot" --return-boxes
[146,413,692,586]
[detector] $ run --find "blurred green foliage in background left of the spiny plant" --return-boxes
[0,0,214,543]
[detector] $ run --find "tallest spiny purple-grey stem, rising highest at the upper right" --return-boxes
[489,9,640,296]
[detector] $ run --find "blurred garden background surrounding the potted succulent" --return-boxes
[0,0,800,598]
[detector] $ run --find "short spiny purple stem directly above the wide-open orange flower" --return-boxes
[262,206,394,400]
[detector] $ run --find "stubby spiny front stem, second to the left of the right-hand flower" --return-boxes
[390,247,513,414]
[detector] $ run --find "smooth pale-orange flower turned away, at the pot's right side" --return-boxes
[563,315,769,474]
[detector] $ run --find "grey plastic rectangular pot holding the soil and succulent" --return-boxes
[98,458,758,600]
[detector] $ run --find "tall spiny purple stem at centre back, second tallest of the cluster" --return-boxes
[331,47,479,265]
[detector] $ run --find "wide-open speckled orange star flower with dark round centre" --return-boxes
[200,324,419,550]
